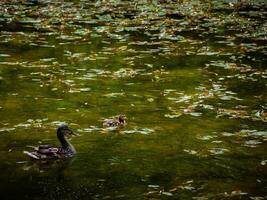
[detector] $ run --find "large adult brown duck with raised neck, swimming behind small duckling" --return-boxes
[24,124,78,160]
